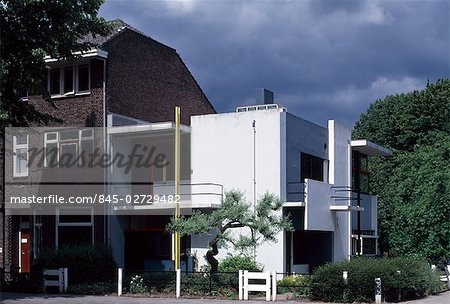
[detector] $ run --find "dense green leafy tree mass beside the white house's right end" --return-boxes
[352,80,450,263]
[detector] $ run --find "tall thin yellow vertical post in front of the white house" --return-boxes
[174,107,181,270]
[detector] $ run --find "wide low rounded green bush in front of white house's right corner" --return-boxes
[310,258,436,302]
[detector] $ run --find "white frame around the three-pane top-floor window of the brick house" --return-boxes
[47,61,91,98]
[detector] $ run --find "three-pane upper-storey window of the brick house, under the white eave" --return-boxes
[47,63,91,97]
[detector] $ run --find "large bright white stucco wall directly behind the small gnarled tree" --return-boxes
[191,110,285,271]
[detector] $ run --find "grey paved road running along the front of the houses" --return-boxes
[0,291,450,304]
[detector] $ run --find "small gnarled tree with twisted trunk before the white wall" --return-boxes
[166,191,293,272]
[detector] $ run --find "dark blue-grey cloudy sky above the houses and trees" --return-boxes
[100,0,450,126]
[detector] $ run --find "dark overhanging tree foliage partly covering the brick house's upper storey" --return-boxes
[0,0,110,126]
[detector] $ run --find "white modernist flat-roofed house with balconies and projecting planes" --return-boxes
[109,104,391,273]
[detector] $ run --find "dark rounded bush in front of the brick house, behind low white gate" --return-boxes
[32,246,117,286]
